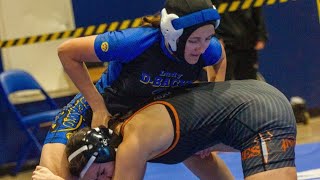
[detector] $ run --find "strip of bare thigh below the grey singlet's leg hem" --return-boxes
[245,167,297,180]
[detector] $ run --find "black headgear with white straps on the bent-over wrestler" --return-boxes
[68,127,122,178]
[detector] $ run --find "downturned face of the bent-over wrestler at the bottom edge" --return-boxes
[83,161,114,180]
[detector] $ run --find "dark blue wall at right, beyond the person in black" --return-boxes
[260,0,320,107]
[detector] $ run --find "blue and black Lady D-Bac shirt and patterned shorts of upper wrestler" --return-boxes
[45,7,222,144]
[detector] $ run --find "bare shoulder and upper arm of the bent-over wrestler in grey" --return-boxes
[113,105,174,180]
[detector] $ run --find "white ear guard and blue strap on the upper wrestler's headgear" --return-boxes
[160,6,220,51]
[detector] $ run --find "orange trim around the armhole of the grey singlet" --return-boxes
[120,101,180,159]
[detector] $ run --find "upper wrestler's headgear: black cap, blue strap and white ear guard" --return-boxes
[160,0,220,51]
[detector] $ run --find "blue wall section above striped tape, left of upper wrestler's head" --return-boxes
[72,0,164,27]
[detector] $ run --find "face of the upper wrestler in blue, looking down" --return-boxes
[184,24,215,64]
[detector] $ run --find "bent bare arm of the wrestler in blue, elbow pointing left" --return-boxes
[58,36,110,128]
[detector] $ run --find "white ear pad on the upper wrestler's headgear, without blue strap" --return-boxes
[160,8,183,51]
